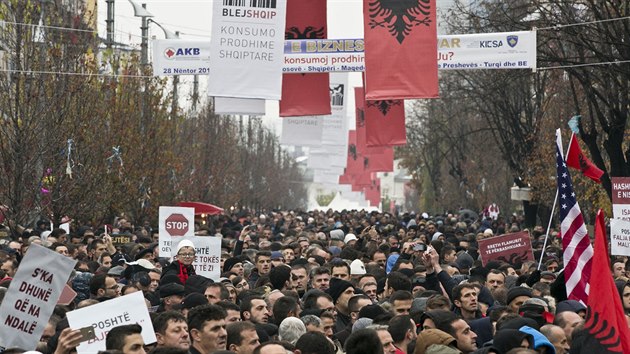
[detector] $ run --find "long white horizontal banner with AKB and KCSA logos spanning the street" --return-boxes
[153,31,536,75]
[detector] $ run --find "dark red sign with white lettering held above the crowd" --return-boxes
[479,231,534,266]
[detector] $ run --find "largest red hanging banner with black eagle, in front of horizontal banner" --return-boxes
[363,0,438,101]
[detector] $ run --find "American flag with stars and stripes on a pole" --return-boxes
[556,129,593,304]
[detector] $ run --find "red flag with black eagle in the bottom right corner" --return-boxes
[571,209,630,354]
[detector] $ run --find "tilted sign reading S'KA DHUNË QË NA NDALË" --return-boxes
[0,244,77,350]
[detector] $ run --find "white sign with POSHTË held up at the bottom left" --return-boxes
[66,291,156,354]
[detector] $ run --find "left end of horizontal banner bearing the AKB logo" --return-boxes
[151,39,210,76]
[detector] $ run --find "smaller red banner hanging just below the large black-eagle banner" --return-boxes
[365,100,407,148]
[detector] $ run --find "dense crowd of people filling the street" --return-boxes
[0,210,630,354]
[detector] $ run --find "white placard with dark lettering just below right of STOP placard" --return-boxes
[171,236,221,281]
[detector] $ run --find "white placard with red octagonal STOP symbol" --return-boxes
[158,206,195,257]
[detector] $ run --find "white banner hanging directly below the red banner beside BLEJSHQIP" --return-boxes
[280,116,324,146]
